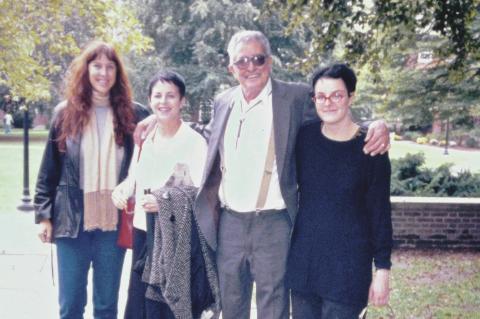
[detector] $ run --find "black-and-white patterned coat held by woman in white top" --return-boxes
[142,183,220,319]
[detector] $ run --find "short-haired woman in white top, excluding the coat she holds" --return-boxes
[112,71,214,319]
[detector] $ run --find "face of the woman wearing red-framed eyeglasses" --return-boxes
[314,78,354,124]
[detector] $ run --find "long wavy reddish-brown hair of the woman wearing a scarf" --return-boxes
[56,41,135,152]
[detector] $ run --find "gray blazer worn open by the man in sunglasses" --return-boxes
[194,79,318,250]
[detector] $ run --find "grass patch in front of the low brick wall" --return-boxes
[367,250,480,319]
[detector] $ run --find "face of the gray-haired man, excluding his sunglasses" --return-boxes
[228,40,272,101]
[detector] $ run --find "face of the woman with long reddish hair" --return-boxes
[88,54,117,95]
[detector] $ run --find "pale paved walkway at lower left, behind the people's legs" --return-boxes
[0,211,256,319]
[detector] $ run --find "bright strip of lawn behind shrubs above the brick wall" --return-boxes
[389,140,480,173]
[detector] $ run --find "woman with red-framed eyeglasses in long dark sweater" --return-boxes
[286,64,392,319]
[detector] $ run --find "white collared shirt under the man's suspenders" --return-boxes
[219,79,286,212]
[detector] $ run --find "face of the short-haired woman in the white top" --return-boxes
[149,81,185,122]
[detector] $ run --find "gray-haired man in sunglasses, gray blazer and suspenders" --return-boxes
[191,31,389,319]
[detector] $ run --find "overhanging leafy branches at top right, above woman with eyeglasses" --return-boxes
[266,0,480,75]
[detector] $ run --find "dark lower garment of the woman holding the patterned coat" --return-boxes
[124,228,175,319]
